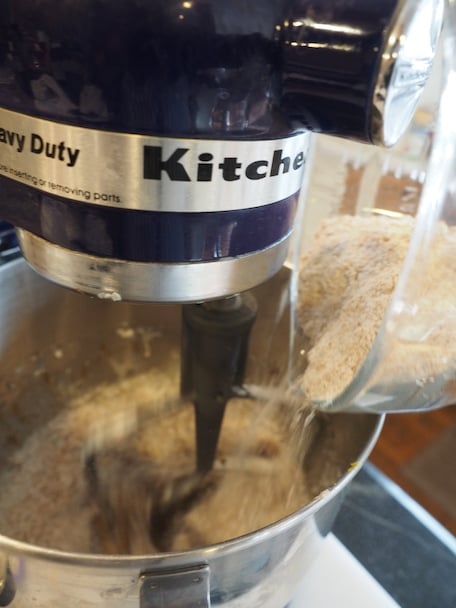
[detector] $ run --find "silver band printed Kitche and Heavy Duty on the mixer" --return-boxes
[0,108,310,212]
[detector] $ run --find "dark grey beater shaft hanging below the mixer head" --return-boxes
[181,294,257,473]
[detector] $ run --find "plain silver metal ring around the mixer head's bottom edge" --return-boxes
[18,230,290,302]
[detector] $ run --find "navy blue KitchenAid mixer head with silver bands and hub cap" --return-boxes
[0,0,443,302]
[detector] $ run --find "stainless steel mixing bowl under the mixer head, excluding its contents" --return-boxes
[0,260,382,608]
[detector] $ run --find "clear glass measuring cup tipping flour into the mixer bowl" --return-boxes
[290,2,456,412]
